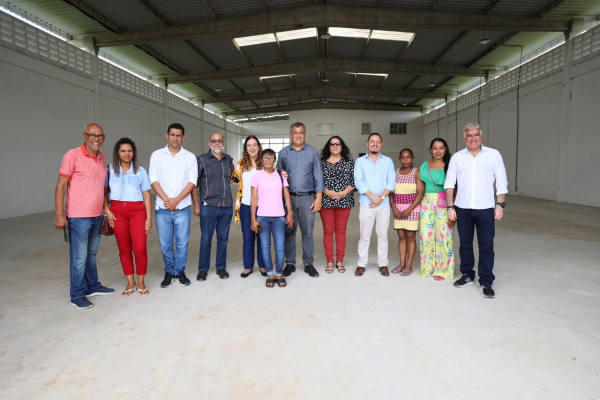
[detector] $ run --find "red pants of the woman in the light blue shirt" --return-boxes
[110,200,148,276]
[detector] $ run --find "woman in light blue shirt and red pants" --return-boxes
[104,138,152,297]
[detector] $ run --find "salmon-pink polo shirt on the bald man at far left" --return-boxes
[58,144,106,218]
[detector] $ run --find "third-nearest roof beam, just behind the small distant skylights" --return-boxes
[202,85,446,103]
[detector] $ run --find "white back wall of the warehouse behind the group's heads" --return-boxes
[244,110,423,165]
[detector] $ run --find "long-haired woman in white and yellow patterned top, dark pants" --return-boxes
[231,135,267,278]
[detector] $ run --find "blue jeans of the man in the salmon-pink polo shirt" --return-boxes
[68,216,102,300]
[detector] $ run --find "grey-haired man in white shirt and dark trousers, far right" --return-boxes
[444,122,508,298]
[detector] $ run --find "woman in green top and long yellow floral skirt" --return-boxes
[419,138,454,281]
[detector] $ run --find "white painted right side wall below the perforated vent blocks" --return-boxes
[423,53,600,207]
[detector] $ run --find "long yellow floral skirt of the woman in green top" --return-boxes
[419,193,454,279]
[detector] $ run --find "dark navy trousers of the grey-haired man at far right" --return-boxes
[456,208,496,285]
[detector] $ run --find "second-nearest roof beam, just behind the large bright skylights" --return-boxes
[166,58,487,85]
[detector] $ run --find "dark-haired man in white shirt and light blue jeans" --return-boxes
[149,123,198,288]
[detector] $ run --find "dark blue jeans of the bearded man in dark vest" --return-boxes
[198,204,233,272]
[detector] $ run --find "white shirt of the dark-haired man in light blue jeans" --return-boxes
[149,145,198,210]
